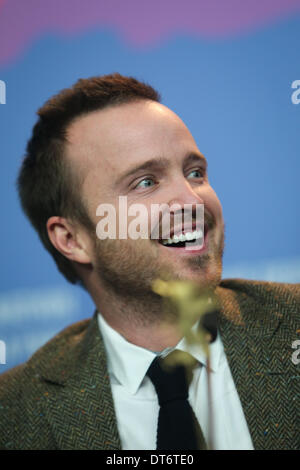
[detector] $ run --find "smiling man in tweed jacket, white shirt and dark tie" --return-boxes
[0,74,300,449]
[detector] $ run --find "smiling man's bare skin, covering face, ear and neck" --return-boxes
[47,95,224,350]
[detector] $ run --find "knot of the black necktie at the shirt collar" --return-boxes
[147,350,197,406]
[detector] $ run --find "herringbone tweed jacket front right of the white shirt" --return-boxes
[218,281,298,449]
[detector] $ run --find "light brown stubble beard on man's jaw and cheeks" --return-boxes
[94,228,225,326]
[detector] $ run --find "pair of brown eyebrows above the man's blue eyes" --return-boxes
[116,152,207,185]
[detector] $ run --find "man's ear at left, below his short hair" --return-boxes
[47,216,92,264]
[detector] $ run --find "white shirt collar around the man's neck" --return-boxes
[98,313,222,395]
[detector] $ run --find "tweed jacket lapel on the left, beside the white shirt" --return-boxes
[37,313,121,450]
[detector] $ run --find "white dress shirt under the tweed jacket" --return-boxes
[98,313,253,450]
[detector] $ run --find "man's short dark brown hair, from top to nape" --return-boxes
[17,73,160,284]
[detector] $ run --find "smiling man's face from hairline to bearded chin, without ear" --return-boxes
[67,101,224,296]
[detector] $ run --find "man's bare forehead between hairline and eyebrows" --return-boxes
[66,101,197,188]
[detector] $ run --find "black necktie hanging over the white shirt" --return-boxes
[147,351,206,450]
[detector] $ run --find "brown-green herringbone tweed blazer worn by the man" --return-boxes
[0,279,300,450]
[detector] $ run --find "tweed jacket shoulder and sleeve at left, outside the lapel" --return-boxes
[0,320,90,449]
